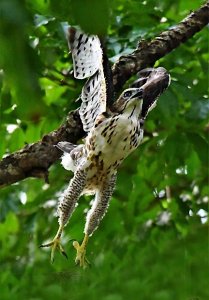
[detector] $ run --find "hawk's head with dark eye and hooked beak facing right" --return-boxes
[113,88,143,113]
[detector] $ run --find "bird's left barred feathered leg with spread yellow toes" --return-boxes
[40,170,86,262]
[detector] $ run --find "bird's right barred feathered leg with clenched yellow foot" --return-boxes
[73,174,116,268]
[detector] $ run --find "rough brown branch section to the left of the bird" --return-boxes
[0,111,84,187]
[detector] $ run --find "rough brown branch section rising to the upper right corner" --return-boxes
[113,1,209,91]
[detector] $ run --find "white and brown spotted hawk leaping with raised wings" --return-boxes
[41,27,170,267]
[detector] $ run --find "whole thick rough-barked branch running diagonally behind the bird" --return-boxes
[0,1,209,187]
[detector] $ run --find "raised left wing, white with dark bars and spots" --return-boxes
[68,27,106,132]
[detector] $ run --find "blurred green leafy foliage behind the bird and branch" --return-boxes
[0,0,209,300]
